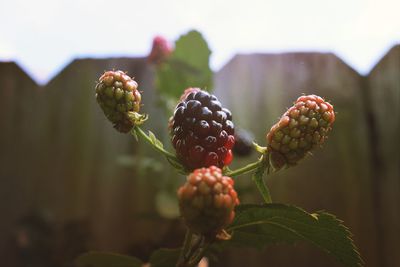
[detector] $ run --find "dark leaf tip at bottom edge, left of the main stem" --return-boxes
[76,252,143,267]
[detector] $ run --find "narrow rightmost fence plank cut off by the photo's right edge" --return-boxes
[366,45,400,266]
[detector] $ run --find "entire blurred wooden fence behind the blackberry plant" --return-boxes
[0,45,400,267]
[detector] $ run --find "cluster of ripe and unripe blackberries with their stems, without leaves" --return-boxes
[91,68,346,266]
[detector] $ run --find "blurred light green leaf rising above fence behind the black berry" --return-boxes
[156,31,212,99]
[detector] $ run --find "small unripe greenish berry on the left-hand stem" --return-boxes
[96,70,141,133]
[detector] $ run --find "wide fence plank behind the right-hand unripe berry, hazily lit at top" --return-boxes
[216,53,377,266]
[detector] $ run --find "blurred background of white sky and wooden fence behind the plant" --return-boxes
[0,0,400,267]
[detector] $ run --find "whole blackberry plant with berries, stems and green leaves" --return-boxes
[77,32,363,267]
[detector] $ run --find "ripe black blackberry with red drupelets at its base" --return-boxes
[171,90,235,170]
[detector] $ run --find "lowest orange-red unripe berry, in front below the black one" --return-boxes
[178,166,239,236]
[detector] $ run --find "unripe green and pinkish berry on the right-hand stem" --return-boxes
[267,95,335,169]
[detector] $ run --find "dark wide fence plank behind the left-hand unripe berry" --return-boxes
[37,58,169,255]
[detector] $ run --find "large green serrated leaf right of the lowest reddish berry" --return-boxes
[221,204,363,266]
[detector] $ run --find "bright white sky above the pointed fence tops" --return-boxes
[0,0,400,84]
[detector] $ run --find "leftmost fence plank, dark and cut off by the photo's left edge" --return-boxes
[0,62,40,264]
